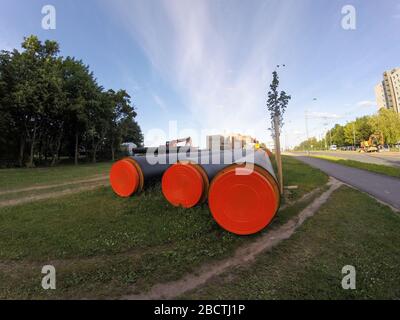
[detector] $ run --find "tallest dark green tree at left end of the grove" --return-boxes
[1,36,59,166]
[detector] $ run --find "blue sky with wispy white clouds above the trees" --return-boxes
[0,0,400,146]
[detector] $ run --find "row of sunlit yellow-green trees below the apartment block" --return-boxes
[295,109,400,150]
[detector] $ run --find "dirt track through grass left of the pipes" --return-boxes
[0,179,109,208]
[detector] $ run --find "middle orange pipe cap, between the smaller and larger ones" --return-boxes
[161,162,209,208]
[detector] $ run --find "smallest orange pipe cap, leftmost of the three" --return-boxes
[110,159,140,198]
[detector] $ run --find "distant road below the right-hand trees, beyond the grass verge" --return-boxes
[311,151,400,167]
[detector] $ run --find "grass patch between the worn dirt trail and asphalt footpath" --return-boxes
[184,187,400,299]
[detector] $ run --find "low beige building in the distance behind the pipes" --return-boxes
[207,134,259,150]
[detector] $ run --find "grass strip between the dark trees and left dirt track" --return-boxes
[0,163,111,192]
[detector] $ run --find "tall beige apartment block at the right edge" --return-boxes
[375,68,400,113]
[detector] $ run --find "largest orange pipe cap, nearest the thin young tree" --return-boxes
[208,165,280,235]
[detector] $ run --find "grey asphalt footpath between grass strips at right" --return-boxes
[292,154,400,210]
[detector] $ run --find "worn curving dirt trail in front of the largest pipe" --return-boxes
[122,178,342,300]
